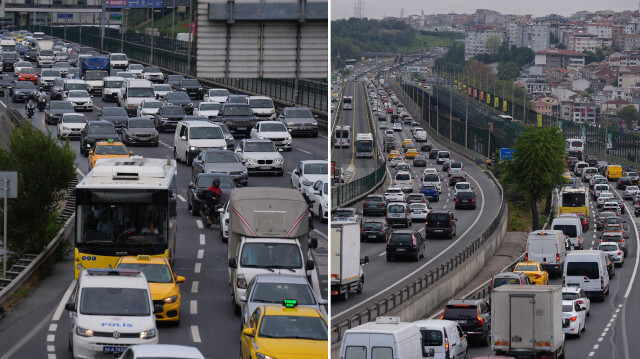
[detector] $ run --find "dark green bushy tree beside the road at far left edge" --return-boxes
[0,125,76,255]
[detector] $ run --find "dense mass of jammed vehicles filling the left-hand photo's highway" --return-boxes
[0,31,329,359]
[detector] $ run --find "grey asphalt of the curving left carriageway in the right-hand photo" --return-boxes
[331,79,501,323]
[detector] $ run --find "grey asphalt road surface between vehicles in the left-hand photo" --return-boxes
[0,56,328,359]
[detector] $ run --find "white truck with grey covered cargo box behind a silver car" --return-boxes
[227,187,318,314]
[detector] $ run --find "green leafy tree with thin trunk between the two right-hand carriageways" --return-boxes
[504,127,567,230]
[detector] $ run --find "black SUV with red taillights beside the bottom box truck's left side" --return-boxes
[441,299,491,347]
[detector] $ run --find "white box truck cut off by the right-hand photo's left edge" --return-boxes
[331,222,369,300]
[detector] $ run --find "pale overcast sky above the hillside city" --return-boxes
[330,0,640,19]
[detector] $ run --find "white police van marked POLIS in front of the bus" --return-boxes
[65,268,163,358]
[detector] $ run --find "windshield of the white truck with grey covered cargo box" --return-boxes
[240,242,302,268]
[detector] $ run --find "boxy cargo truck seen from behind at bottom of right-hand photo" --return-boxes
[491,284,564,359]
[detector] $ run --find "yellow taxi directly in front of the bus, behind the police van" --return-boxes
[116,256,185,324]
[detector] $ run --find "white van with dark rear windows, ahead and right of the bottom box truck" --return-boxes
[562,250,609,301]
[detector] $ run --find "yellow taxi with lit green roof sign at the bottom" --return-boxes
[240,299,329,359]
